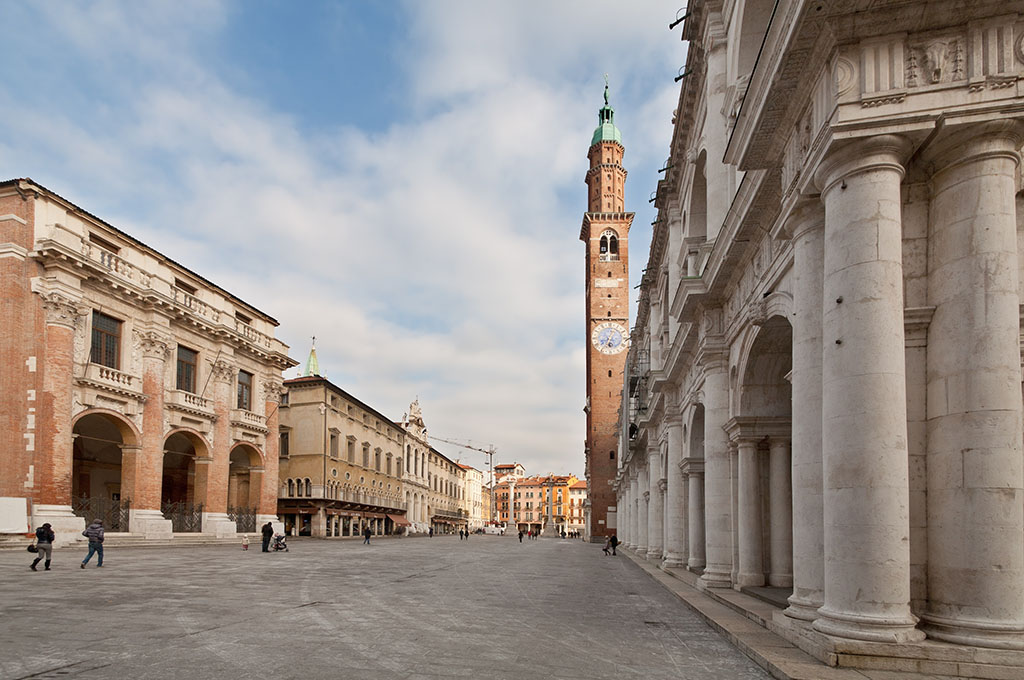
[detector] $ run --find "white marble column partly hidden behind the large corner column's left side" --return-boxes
[785,198,825,621]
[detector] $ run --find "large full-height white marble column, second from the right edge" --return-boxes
[813,135,924,642]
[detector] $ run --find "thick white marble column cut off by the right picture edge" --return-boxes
[924,121,1024,649]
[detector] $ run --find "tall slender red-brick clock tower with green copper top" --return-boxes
[580,84,633,542]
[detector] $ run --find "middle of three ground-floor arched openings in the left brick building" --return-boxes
[160,430,209,533]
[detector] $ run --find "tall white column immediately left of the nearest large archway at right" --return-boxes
[700,352,732,588]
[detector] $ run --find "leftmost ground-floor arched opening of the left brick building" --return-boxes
[71,412,138,532]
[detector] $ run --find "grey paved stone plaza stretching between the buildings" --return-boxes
[0,537,768,680]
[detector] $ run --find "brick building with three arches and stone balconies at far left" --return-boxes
[0,179,295,544]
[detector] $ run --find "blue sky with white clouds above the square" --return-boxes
[0,0,685,477]
